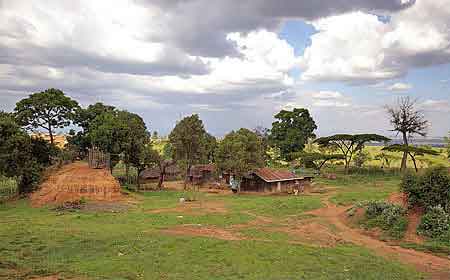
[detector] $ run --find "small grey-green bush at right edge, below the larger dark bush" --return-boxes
[417,205,450,238]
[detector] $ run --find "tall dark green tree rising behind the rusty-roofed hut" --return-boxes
[269,108,317,160]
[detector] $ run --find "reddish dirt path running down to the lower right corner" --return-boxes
[307,194,450,280]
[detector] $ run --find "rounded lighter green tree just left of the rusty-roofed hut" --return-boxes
[216,128,264,190]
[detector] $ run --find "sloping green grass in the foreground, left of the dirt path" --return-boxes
[0,191,421,280]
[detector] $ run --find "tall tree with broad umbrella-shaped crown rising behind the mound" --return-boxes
[14,88,79,144]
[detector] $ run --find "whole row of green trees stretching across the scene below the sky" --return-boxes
[0,88,446,193]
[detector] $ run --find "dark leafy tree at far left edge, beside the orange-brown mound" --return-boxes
[0,112,52,194]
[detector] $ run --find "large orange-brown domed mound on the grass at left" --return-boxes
[31,162,122,206]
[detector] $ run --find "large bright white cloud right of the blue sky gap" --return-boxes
[301,0,450,83]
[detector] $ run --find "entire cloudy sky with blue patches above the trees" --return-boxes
[0,0,450,136]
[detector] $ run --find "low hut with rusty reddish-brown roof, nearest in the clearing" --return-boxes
[240,167,312,193]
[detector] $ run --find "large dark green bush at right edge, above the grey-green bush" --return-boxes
[401,167,450,212]
